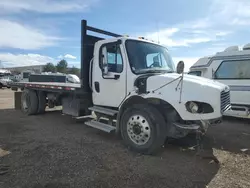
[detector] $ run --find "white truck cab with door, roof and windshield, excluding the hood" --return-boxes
[90,37,175,107]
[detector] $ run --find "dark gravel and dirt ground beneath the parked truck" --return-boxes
[0,89,250,188]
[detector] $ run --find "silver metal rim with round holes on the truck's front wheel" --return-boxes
[127,115,151,145]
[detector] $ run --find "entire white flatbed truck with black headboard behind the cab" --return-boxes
[11,20,230,154]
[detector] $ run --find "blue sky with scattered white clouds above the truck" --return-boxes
[0,0,250,71]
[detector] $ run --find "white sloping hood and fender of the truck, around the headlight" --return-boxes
[142,73,229,120]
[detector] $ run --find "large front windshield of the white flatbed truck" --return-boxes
[126,40,175,74]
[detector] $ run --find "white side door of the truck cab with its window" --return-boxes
[92,41,126,107]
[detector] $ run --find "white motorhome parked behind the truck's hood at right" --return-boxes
[188,43,250,118]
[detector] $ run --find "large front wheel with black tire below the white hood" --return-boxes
[121,104,167,155]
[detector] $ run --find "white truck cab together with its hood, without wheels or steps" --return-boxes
[90,37,229,120]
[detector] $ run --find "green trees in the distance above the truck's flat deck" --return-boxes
[43,59,80,76]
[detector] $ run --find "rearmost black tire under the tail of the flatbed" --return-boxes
[21,90,38,115]
